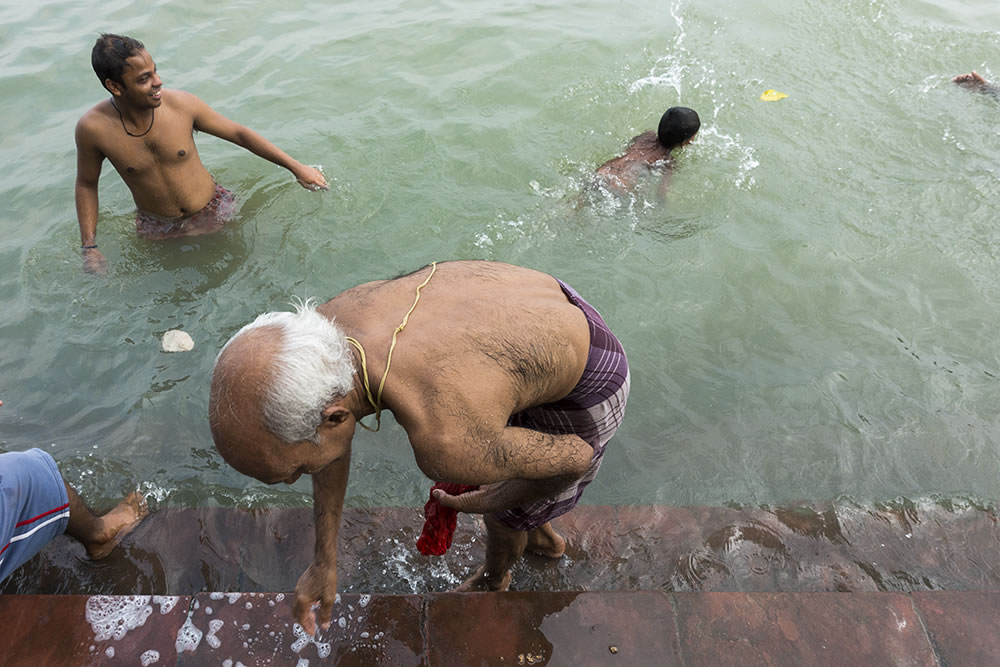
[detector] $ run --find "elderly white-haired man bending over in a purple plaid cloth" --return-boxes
[209,261,629,633]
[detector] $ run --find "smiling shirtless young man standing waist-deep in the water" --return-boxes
[76,34,327,273]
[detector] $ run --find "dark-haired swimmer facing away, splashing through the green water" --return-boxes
[596,107,701,199]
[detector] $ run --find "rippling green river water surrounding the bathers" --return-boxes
[0,0,1000,520]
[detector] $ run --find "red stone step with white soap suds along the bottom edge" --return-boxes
[0,592,1000,667]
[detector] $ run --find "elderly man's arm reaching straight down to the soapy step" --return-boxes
[295,451,351,636]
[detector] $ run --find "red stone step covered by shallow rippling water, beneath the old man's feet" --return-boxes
[0,504,1000,595]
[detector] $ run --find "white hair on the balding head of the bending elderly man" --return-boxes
[215,299,354,443]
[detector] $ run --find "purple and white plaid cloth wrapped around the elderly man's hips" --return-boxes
[493,280,629,530]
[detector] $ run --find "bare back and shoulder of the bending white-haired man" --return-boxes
[319,262,589,472]
